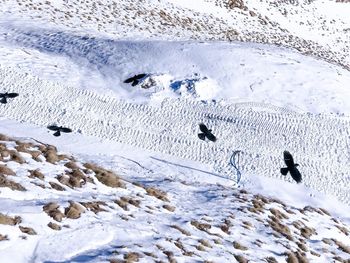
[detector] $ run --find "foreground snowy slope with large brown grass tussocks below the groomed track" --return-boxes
[0,135,350,262]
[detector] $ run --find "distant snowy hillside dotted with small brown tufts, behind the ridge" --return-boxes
[0,0,350,68]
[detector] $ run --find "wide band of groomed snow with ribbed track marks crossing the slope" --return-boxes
[0,68,350,203]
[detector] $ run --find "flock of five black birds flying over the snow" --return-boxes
[0,86,302,183]
